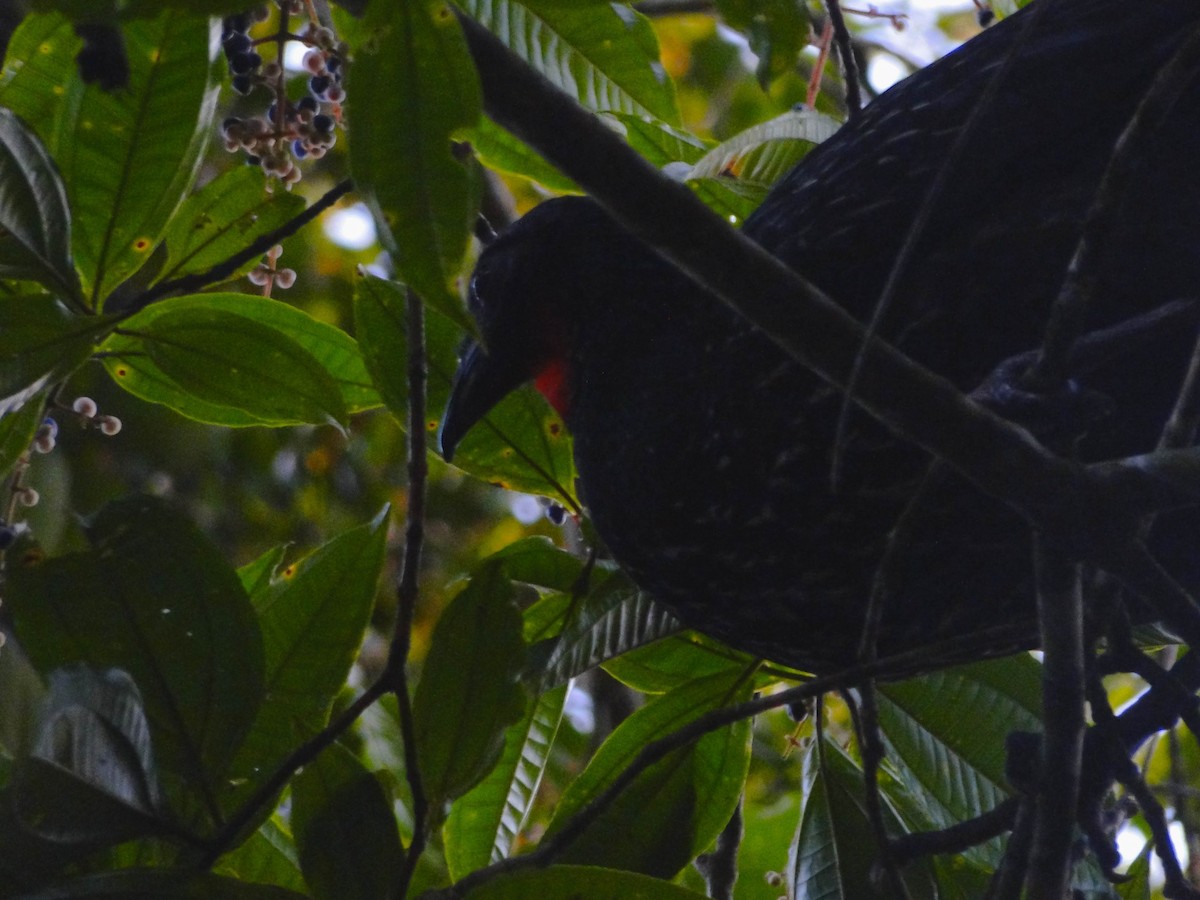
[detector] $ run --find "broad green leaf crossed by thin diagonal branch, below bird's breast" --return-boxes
[547,672,752,878]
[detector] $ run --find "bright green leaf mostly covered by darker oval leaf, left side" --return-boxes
[101,294,380,426]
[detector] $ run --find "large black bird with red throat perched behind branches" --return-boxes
[439,0,1200,677]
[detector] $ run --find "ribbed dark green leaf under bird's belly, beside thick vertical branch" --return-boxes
[878,654,1042,868]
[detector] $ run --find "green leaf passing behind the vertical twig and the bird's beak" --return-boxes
[354,276,577,506]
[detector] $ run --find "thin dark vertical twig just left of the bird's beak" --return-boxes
[385,290,430,900]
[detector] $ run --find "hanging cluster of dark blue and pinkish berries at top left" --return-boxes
[221,0,348,185]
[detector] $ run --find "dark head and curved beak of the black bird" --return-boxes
[439,197,632,460]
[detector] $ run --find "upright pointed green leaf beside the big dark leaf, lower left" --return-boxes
[227,508,390,806]
